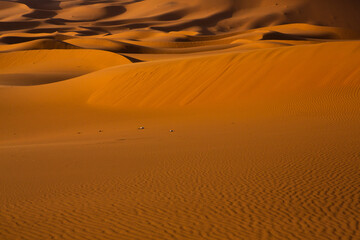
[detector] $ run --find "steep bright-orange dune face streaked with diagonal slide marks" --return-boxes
[81,41,360,108]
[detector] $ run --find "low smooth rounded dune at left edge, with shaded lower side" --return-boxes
[0,48,131,86]
